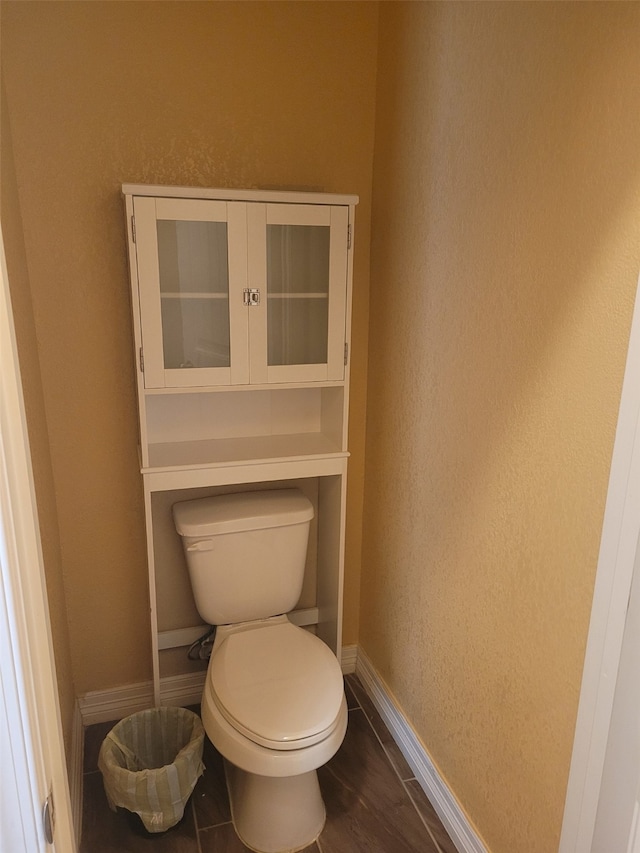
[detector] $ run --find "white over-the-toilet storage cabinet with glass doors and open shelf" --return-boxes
[123,184,358,703]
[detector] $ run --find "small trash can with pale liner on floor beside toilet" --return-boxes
[98,708,204,833]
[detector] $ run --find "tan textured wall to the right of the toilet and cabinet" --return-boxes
[360,3,640,853]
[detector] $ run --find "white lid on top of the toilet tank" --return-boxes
[173,489,313,536]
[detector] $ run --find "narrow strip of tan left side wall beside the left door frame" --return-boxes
[0,80,76,760]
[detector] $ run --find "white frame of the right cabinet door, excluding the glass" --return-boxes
[247,202,349,384]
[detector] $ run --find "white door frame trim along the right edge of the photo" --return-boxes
[559,268,640,853]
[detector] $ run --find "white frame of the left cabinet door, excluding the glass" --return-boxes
[133,197,249,388]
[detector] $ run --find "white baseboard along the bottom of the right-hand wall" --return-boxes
[355,649,488,853]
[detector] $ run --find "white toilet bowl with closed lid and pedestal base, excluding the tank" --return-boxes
[202,616,347,853]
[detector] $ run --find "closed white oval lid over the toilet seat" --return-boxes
[209,622,344,749]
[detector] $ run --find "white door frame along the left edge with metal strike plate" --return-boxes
[0,231,77,853]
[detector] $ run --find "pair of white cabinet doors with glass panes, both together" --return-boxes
[133,196,349,388]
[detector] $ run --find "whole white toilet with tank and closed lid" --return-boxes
[173,489,347,853]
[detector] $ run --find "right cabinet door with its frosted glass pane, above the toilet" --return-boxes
[248,204,348,382]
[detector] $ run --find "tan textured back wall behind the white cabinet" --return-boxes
[1,0,377,694]
